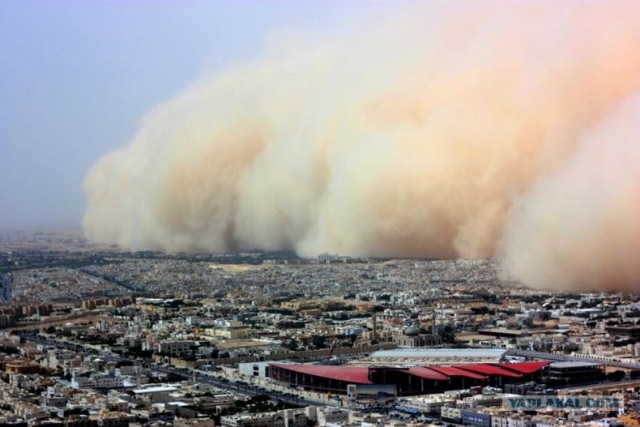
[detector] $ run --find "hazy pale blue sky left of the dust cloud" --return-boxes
[0,0,360,229]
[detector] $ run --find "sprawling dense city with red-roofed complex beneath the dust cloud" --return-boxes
[0,232,640,427]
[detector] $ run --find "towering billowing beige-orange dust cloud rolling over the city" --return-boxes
[84,2,640,290]
